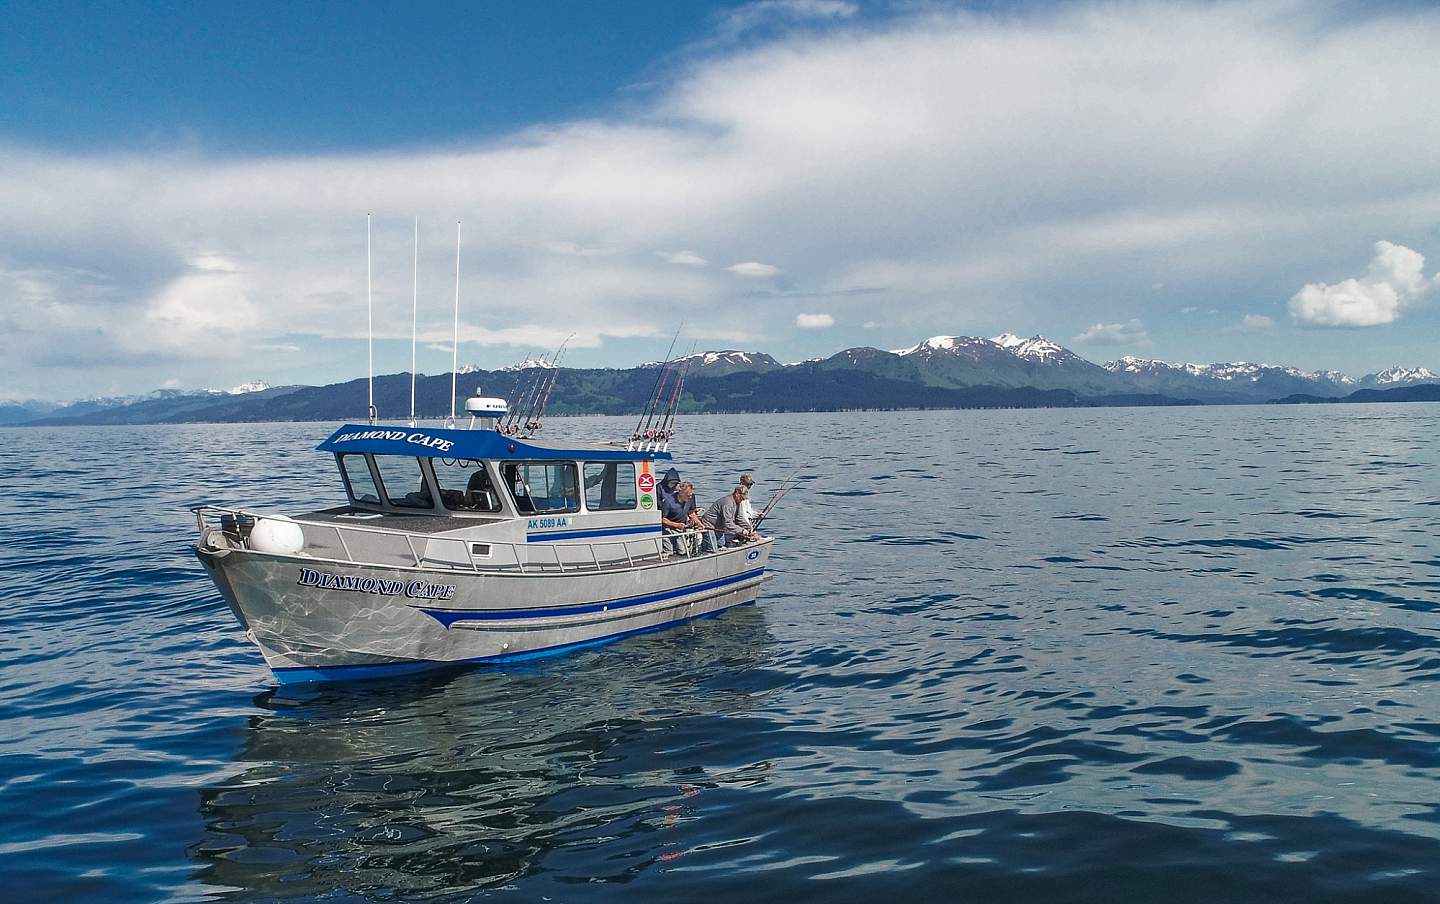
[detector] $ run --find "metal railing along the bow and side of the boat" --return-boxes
[190,505,725,574]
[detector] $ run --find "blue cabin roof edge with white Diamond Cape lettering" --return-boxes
[317,423,671,462]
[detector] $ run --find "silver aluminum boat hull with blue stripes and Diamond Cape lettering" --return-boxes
[196,540,772,684]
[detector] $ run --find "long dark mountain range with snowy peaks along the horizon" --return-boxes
[0,333,1440,425]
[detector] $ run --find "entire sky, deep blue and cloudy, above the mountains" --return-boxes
[0,0,1440,399]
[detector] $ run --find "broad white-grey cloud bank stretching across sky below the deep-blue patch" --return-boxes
[0,1,1440,394]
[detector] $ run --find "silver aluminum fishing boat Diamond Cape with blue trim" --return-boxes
[192,226,773,684]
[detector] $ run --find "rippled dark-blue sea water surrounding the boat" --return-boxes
[0,404,1440,904]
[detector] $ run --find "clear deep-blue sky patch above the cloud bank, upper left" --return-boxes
[0,1,723,155]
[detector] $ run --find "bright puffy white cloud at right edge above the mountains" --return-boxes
[1289,240,1440,327]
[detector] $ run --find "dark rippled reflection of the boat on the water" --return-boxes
[190,606,775,900]
